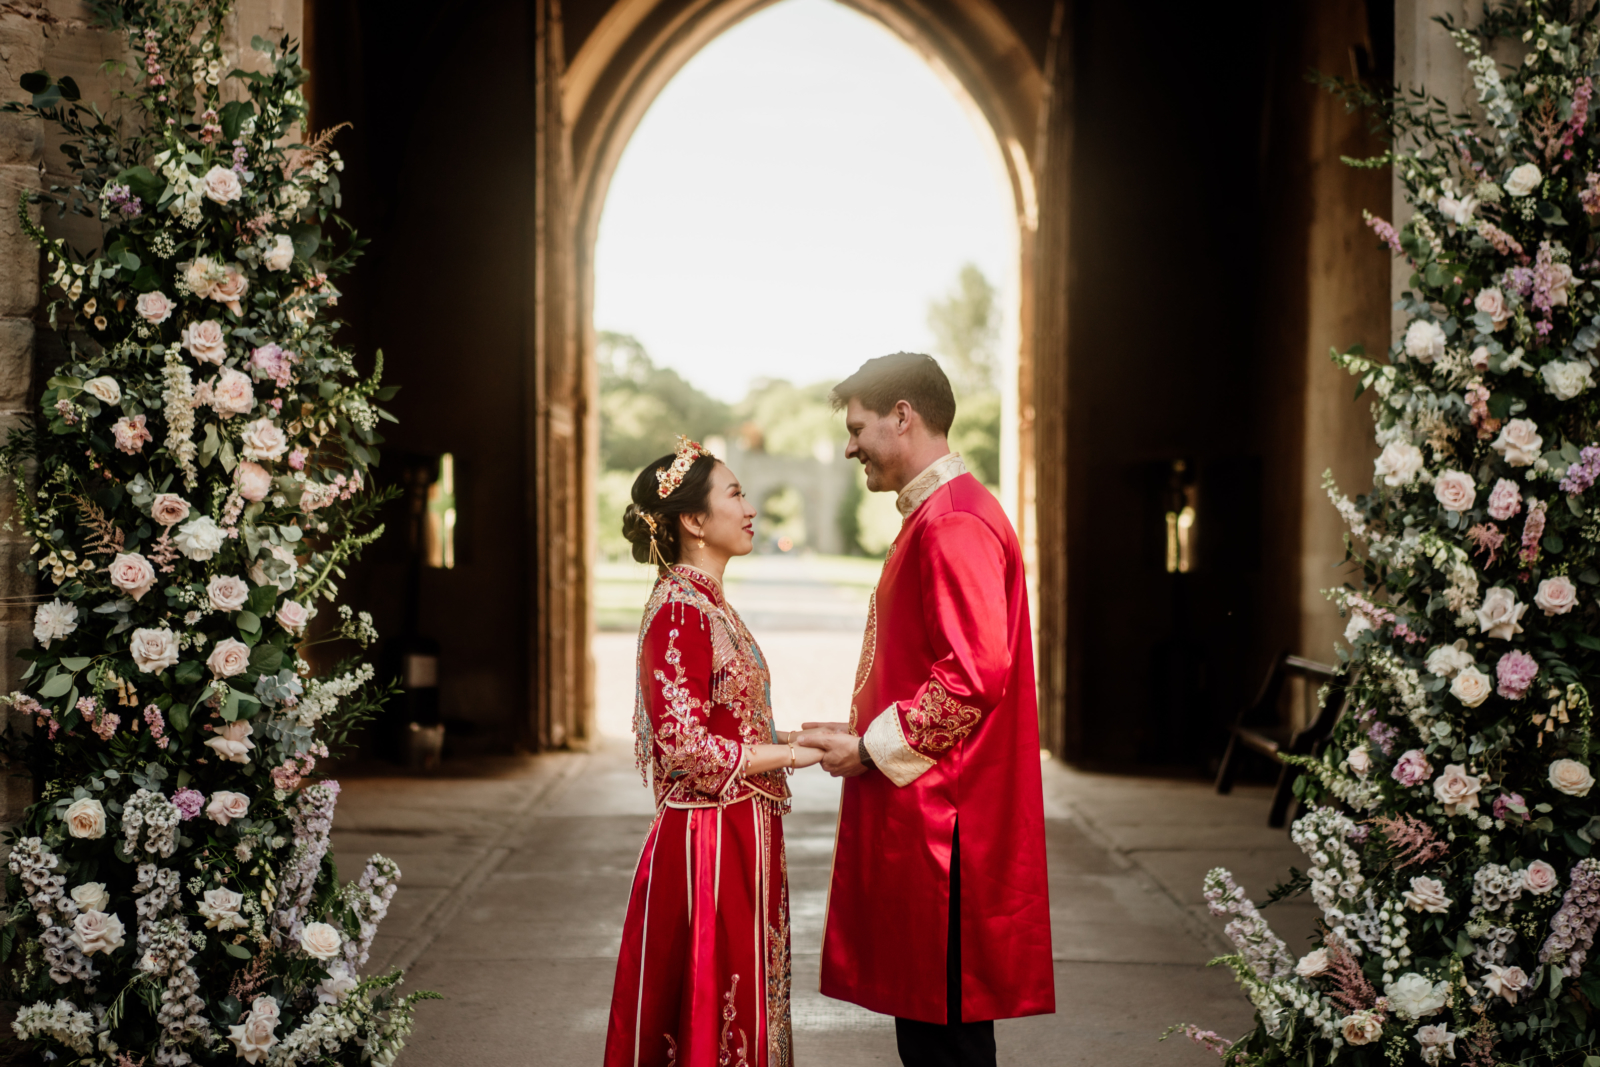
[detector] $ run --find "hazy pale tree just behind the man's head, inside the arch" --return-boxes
[928,264,1000,488]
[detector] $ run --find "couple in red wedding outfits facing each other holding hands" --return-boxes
[605,354,1054,1067]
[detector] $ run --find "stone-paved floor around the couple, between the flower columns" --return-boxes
[334,633,1312,1067]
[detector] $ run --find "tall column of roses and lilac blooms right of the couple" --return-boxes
[1184,8,1600,1067]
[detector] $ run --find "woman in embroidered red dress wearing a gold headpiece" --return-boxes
[605,437,822,1067]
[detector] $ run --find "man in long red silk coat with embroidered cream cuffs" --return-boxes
[798,352,1056,1067]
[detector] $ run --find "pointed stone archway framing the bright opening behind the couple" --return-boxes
[528,0,1070,752]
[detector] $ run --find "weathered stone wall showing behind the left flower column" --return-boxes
[0,0,301,827]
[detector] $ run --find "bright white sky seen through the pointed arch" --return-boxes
[595,0,1016,400]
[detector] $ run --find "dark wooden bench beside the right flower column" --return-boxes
[1216,653,1349,827]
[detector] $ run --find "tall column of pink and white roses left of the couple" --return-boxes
[0,0,427,1067]
